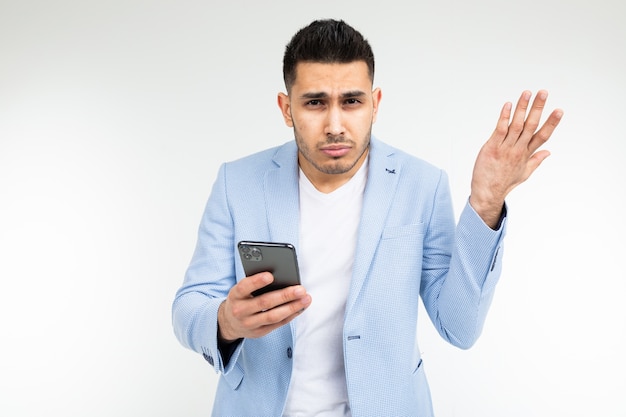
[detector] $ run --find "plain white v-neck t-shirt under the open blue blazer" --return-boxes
[283,160,368,417]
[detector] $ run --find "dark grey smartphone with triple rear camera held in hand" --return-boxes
[237,241,300,296]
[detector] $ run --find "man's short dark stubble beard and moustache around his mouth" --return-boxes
[294,126,372,174]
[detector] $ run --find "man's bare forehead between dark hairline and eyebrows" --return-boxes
[292,61,372,91]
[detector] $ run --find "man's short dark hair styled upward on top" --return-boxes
[283,19,374,91]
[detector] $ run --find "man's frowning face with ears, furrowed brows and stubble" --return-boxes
[278,61,381,191]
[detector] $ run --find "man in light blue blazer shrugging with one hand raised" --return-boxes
[173,20,562,417]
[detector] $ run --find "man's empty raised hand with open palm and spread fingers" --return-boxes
[470,90,563,228]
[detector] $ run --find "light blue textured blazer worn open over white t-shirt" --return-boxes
[172,138,506,417]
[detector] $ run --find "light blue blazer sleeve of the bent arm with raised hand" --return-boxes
[420,169,506,349]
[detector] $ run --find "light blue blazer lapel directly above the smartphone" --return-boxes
[264,141,300,249]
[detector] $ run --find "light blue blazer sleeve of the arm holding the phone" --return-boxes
[172,165,241,372]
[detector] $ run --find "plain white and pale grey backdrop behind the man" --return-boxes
[0,0,626,417]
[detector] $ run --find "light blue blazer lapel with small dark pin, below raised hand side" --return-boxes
[346,137,401,311]
